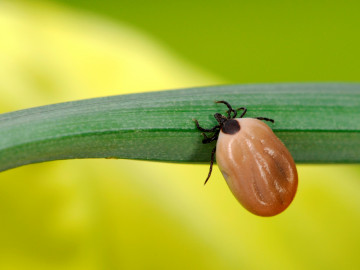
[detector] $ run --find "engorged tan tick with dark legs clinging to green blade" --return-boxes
[194,101,298,216]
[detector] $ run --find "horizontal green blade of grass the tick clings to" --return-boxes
[0,83,360,171]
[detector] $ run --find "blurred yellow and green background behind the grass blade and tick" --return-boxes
[0,0,360,269]
